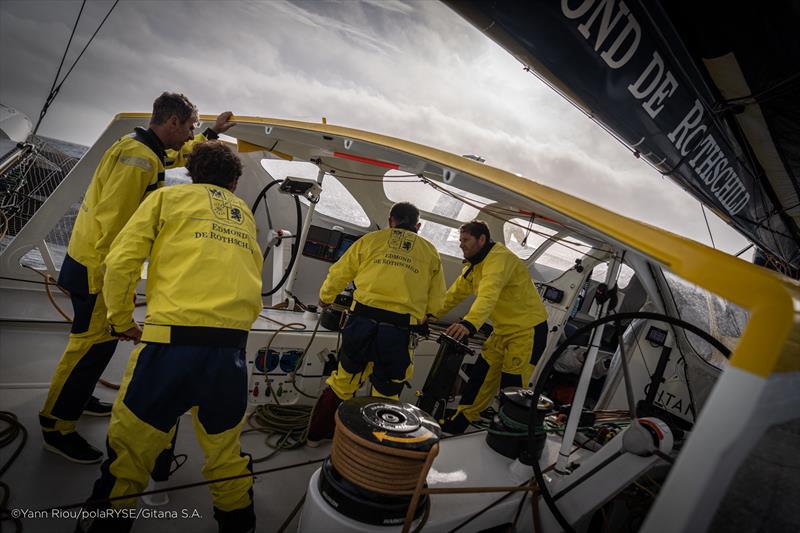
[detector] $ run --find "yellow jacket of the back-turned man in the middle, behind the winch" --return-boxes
[319,228,445,323]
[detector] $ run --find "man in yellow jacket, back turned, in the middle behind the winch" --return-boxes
[308,202,445,447]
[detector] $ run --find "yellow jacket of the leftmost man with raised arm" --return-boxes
[67,128,211,294]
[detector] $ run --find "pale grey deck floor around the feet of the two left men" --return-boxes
[0,387,329,533]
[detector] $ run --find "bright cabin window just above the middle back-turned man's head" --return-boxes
[383,170,492,222]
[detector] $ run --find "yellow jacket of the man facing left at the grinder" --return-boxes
[434,243,547,335]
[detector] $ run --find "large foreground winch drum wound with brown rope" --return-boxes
[303,397,441,531]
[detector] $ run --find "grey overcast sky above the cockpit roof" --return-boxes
[0,0,746,253]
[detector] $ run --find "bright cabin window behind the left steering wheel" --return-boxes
[261,159,370,228]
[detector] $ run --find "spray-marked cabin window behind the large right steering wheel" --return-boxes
[664,272,750,368]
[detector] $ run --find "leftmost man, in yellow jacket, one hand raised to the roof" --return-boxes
[39,93,233,463]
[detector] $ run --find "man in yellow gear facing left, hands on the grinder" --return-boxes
[435,220,547,433]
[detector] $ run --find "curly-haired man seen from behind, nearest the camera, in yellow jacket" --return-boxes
[80,141,262,532]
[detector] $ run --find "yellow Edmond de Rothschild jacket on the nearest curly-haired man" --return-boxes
[103,183,262,343]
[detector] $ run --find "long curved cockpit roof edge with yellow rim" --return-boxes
[112,114,800,376]
